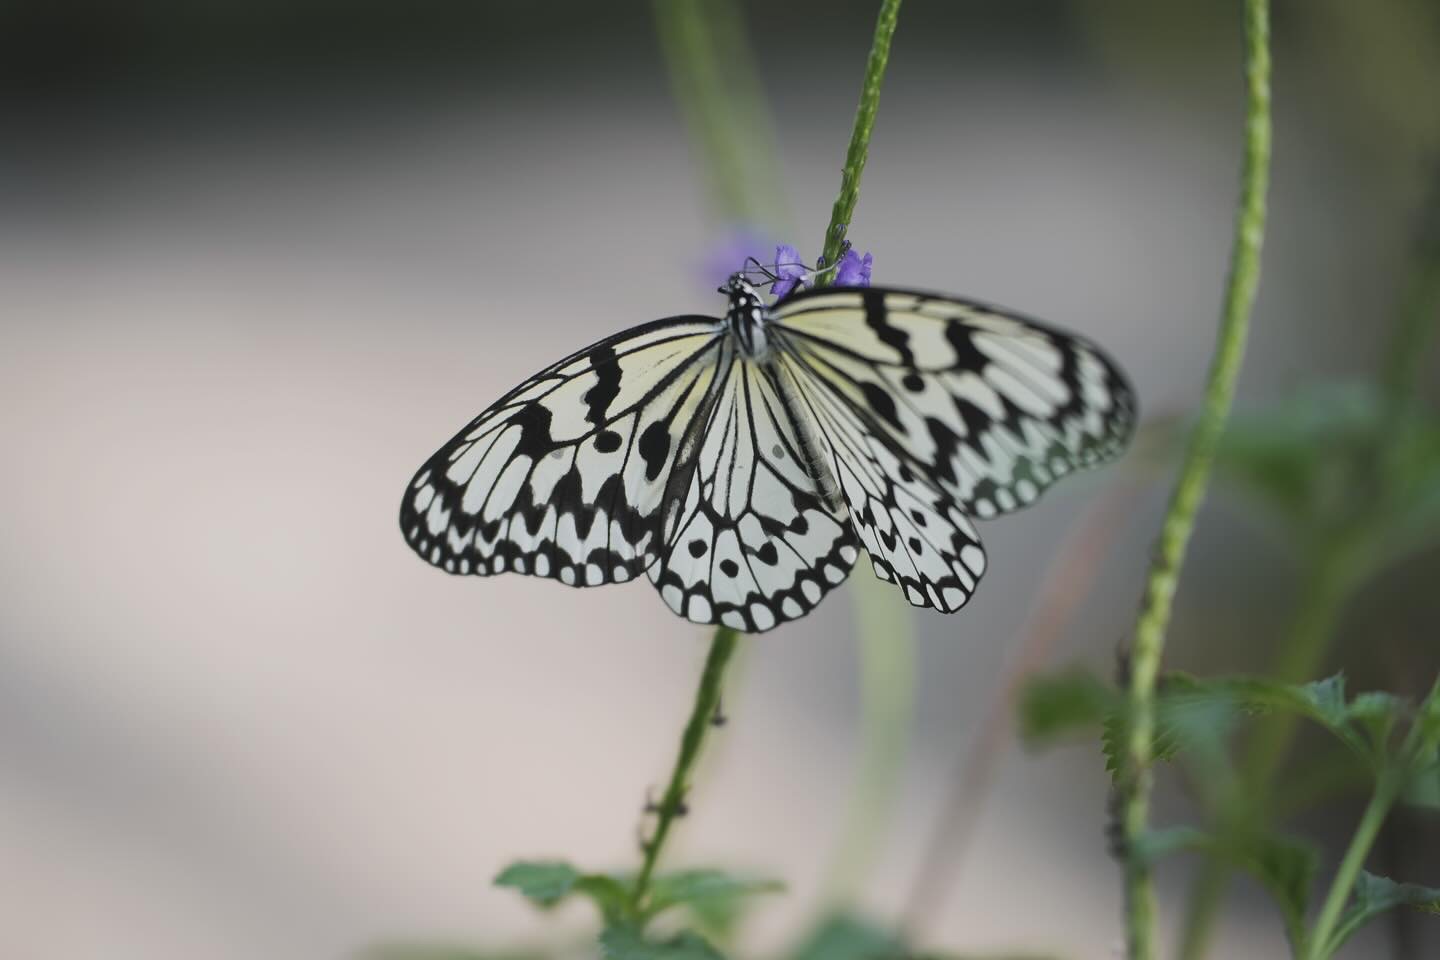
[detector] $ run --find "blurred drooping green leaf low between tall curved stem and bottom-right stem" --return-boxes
[1135,826,1319,944]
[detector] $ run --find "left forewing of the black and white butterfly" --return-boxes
[400,317,724,587]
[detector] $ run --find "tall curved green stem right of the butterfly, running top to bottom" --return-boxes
[1120,0,1270,960]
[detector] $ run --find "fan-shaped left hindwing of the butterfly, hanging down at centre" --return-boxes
[649,343,858,633]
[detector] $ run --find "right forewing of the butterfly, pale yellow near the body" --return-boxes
[770,288,1136,518]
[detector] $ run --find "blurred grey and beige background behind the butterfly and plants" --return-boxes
[0,0,1440,960]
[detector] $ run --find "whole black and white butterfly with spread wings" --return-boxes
[400,273,1136,632]
